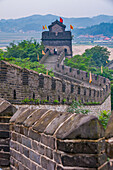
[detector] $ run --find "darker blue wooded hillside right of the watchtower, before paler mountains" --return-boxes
[74,23,113,37]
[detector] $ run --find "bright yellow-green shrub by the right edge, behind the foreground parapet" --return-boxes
[98,110,111,129]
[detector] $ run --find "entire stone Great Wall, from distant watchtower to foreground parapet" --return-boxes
[0,21,113,170]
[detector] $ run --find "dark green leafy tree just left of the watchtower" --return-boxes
[4,38,44,61]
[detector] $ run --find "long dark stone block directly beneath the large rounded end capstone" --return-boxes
[57,139,105,154]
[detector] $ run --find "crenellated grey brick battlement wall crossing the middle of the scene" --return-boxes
[0,61,110,104]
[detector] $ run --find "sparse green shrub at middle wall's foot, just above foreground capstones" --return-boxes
[67,100,89,114]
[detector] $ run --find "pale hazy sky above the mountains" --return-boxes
[0,0,113,19]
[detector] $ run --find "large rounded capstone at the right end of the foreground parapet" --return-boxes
[56,114,104,139]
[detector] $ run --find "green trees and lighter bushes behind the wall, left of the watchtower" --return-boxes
[0,38,54,76]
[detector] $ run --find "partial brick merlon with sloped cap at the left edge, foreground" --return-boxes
[0,98,16,167]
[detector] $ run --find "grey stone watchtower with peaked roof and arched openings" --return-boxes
[42,20,72,56]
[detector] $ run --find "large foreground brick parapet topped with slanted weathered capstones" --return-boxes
[10,108,110,170]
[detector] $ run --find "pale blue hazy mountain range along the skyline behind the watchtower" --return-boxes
[0,14,113,33]
